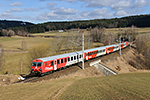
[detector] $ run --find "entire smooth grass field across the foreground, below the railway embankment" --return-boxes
[0,73,150,100]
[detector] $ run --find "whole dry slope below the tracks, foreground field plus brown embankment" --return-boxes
[0,44,150,100]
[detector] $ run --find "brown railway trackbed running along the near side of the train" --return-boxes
[15,47,130,83]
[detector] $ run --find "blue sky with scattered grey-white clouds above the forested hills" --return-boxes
[0,0,150,24]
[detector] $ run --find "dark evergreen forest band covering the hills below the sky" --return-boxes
[0,14,150,36]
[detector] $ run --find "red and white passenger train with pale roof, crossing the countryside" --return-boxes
[31,41,129,75]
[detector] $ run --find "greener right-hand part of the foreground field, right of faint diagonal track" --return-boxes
[59,73,150,100]
